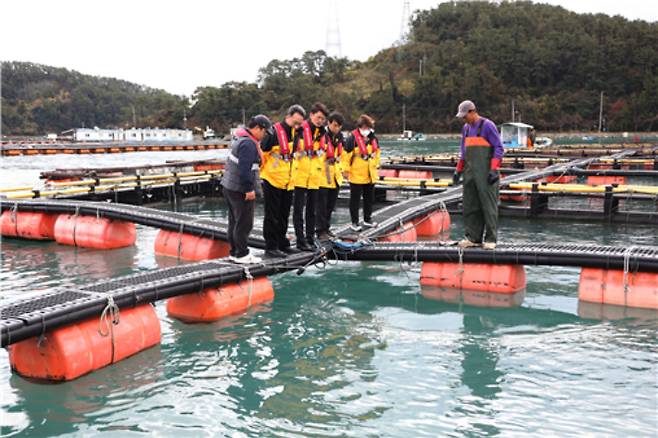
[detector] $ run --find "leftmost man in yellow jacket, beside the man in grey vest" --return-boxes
[260,105,306,258]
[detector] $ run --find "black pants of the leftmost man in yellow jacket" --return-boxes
[263,180,292,249]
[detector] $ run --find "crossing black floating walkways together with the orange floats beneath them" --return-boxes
[5,150,658,380]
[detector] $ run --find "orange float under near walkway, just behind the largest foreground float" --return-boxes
[167,277,274,322]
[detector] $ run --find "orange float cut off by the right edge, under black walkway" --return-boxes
[578,268,658,309]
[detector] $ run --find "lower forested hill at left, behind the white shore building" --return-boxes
[2,62,189,135]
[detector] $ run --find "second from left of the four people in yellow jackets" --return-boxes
[290,103,329,251]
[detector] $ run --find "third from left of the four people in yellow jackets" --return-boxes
[316,111,345,241]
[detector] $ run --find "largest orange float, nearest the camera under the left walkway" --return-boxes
[8,304,160,380]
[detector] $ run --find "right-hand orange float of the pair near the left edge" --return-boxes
[55,214,137,249]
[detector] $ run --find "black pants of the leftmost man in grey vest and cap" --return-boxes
[224,188,256,257]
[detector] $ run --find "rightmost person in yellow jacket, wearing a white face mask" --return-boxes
[343,114,381,231]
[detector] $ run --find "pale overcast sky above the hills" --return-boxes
[0,0,658,95]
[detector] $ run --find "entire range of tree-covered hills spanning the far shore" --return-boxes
[2,1,658,134]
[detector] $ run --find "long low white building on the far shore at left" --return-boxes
[73,128,194,142]
